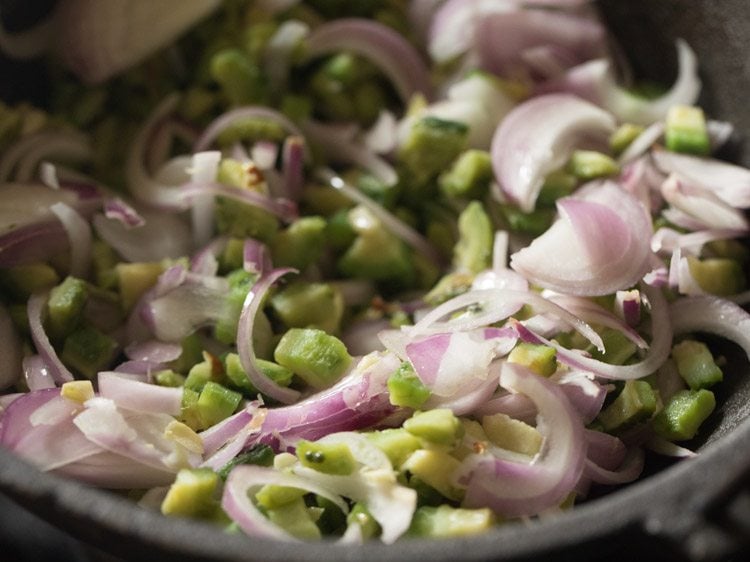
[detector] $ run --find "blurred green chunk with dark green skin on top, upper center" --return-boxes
[398,117,469,185]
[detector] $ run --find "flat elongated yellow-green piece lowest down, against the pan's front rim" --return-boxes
[408,505,496,538]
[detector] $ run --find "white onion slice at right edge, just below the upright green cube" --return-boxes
[651,150,750,209]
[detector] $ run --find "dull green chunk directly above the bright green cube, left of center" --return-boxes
[270,282,344,333]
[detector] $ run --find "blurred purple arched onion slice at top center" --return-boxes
[306,18,432,103]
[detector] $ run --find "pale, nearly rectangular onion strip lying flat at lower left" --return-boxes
[97,371,183,416]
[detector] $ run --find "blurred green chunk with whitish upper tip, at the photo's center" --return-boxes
[337,207,414,286]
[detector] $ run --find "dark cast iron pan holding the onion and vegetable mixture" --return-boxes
[0,0,750,562]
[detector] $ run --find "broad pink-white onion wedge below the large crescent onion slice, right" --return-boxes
[511,182,651,296]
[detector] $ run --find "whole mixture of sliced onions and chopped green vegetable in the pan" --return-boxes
[0,0,750,543]
